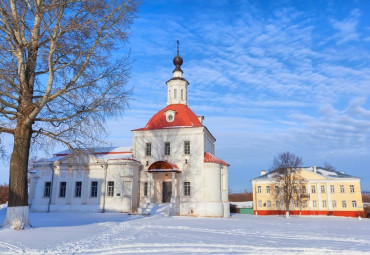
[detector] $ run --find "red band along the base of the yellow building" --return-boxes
[253,210,365,218]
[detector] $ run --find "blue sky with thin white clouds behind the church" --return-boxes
[0,1,370,191]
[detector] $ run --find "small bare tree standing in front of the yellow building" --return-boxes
[271,152,305,218]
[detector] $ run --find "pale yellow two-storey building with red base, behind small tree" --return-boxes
[251,166,364,217]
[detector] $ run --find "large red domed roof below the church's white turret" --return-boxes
[134,104,203,131]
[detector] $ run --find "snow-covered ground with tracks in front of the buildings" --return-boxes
[0,205,370,255]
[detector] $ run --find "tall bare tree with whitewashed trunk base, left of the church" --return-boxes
[0,0,139,229]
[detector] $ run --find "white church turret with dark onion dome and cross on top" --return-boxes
[166,40,189,105]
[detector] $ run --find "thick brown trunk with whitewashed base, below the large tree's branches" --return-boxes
[3,126,32,229]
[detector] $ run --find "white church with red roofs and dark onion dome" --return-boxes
[29,47,230,217]
